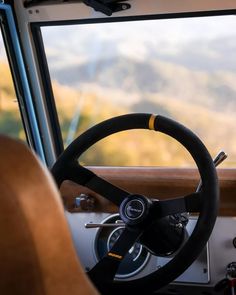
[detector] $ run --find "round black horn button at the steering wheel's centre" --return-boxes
[120,195,152,225]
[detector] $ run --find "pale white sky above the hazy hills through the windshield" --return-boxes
[39,16,236,70]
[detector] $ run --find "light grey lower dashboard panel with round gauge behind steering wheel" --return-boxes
[67,213,236,295]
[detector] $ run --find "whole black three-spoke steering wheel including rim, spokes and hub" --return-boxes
[52,114,219,294]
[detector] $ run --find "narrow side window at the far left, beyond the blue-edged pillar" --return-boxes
[0,29,26,141]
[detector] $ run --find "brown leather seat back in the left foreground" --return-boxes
[0,136,97,295]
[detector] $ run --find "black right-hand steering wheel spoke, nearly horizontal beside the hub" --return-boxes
[152,192,201,218]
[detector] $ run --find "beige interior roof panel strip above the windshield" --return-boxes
[15,0,236,23]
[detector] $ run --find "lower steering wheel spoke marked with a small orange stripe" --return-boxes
[88,227,143,291]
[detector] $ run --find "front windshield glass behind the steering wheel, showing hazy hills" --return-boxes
[42,16,236,167]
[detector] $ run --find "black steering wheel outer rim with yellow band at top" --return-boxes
[52,114,219,293]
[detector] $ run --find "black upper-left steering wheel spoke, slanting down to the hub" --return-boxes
[67,163,129,206]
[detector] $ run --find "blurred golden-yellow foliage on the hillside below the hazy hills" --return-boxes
[54,77,236,167]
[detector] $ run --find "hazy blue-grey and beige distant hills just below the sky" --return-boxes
[51,57,236,112]
